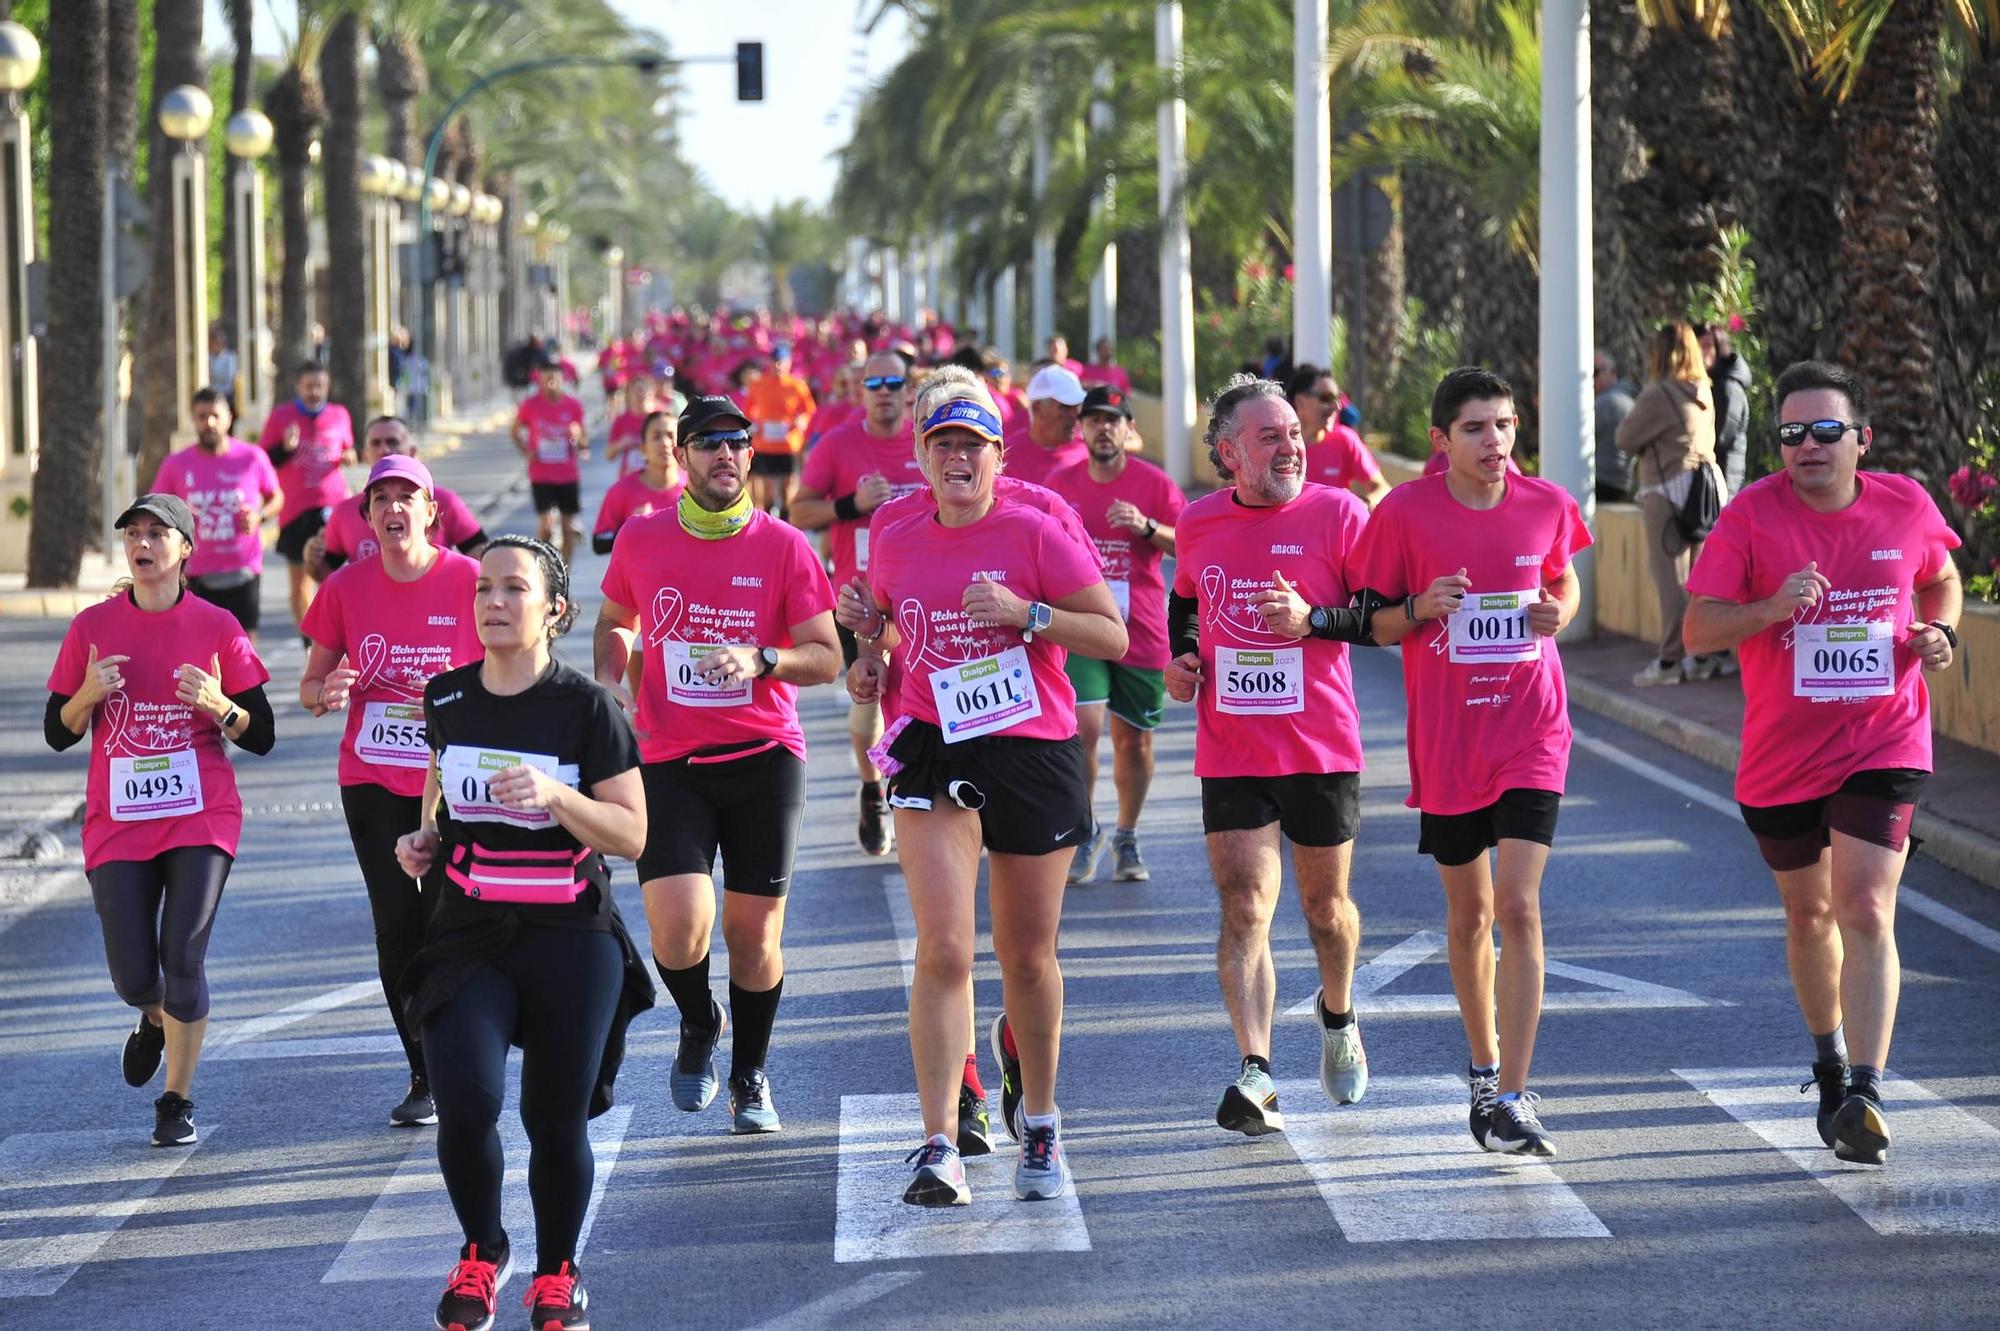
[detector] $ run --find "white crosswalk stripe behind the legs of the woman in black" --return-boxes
[320,1095,632,1285]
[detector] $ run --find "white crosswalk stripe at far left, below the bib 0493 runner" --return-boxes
[0,1123,216,1299]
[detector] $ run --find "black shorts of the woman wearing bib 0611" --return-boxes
[888,721,1090,855]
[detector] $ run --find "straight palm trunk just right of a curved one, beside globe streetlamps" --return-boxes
[320,10,374,422]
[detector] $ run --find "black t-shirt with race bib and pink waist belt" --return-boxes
[424,662,638,935]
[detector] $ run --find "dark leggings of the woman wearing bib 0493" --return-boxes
[86,845,234,1021]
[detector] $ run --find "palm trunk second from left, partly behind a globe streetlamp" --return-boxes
[134,0,208,499]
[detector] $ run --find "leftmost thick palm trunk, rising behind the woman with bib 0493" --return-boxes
[28,0,110,588]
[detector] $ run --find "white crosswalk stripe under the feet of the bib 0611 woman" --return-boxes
[834,1091,1090,1263]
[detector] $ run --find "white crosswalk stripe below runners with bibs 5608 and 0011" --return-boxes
[1278,1077,1612,1243]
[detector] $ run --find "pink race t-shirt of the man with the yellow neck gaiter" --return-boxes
[602,510,834,763]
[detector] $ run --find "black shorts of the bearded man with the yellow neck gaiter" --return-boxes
[638,741,806,897]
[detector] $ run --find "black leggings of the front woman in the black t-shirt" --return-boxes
[424,923,624,1271]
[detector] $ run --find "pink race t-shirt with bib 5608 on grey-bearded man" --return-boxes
[1174,482,1368,777]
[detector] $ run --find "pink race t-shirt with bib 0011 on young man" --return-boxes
[1348,476,1590,813]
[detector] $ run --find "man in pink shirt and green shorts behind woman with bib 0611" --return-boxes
[1048,386,1186,885]
